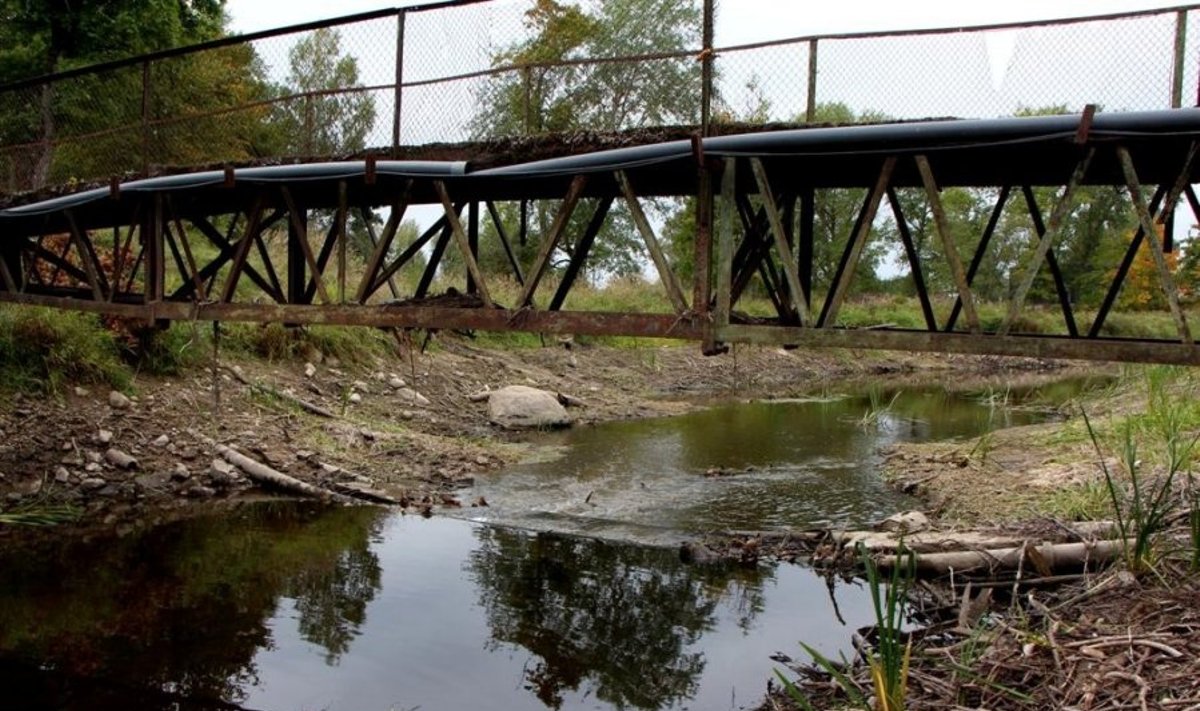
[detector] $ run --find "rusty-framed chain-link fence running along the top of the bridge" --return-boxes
[0,0,1200,192]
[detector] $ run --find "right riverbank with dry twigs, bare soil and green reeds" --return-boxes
[761,368,1200,711]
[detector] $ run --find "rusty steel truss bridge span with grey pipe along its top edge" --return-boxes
[0,109,1200,364]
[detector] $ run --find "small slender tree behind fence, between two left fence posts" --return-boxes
[277,28,376,155]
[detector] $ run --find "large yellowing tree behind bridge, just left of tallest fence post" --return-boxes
[458,0,701,288]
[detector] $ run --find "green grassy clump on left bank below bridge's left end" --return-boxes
[0,305,130,393]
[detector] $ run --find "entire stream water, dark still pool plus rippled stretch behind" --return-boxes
[0,384,1094,711]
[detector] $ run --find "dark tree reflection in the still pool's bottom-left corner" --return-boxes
[0,503,383,709]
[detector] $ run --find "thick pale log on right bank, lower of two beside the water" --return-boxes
[876,540,1122,574]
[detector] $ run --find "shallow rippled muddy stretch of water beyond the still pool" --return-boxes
[462,384,1072,543]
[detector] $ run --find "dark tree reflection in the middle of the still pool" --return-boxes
[469,527,762,709]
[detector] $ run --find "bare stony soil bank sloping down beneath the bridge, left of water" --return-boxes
[0,335,1061,533]
